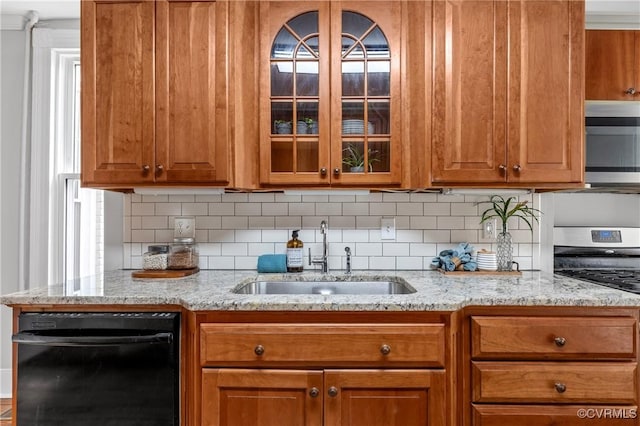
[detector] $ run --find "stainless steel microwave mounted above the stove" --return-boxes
[585,101,640,186]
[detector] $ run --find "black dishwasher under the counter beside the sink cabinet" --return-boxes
[13,312,180,426]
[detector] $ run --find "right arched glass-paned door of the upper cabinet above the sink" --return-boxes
[331,2,401,185]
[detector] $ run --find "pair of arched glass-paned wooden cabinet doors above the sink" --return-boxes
[259,2,400,186]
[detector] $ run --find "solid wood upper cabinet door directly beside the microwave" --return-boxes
[507,0,584,182]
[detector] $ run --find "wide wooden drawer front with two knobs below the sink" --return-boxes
[200,323,445,367]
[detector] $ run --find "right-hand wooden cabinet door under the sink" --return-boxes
[324,370,446,426]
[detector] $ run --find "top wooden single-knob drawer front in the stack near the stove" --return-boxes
[471,316,637,360]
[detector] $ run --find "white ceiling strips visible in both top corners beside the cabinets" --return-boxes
[0,0,640,21]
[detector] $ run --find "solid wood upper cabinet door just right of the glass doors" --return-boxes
[432,0,507,182]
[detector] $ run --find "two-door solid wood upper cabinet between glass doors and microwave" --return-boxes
[431,0,584,187]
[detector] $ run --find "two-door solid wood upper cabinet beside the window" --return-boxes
[81,0,230,188]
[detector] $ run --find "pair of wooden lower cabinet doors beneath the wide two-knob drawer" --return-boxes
[202,368,446,426]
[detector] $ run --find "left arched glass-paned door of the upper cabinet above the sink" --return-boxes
[260,2,330,184]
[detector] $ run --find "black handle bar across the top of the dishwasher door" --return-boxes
[11,332,173,346]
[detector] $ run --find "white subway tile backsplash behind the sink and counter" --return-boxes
[123,192,540,271]
